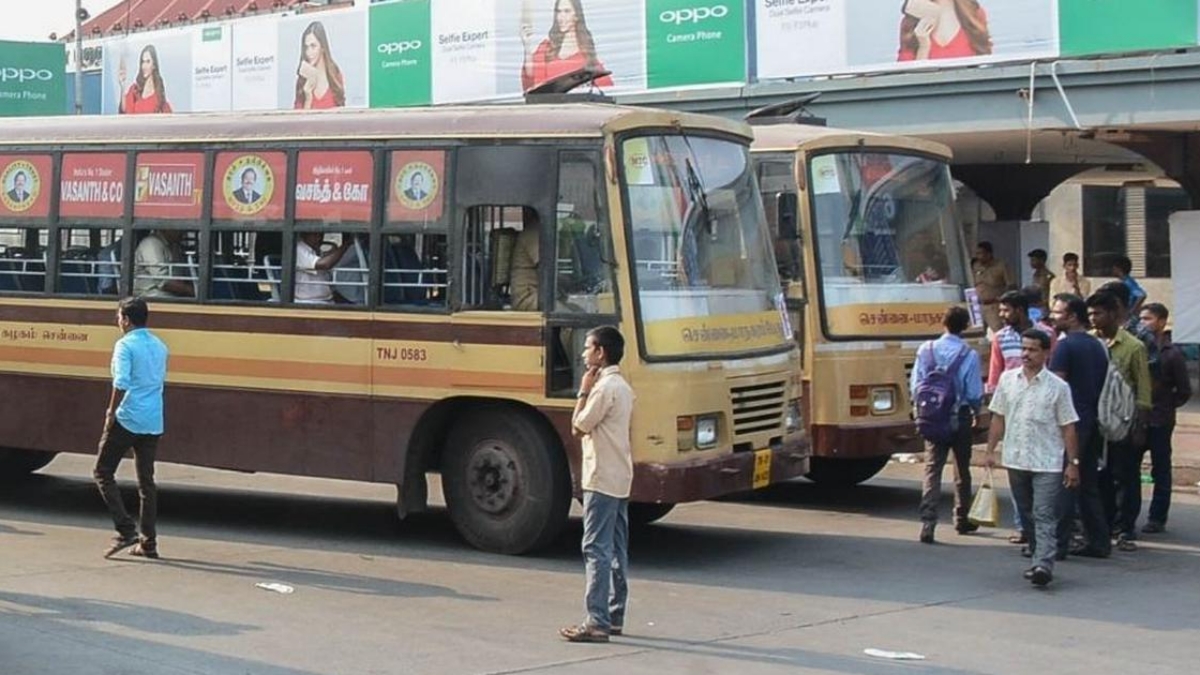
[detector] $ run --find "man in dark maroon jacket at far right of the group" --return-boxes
[1129,303,1192,534]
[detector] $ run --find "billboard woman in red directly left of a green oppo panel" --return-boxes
[521,0,612,91]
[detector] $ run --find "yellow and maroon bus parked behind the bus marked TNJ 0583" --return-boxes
[748,110,986,486]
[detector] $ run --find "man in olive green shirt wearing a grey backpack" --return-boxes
[1087,291,1151,551]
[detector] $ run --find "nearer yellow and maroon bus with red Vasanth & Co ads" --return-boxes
[0,103,810,554]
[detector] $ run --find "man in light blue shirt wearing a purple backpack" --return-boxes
[908,306,983,544]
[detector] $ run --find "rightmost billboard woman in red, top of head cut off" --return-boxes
[898,0,991,61]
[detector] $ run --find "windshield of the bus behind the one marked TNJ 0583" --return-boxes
[809,150,970,336]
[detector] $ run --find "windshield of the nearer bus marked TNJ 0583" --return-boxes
[622,135,791,358]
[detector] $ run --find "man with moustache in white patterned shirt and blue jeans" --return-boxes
[986,328,1079,586]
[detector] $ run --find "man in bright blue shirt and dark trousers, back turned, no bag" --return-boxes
[92,298,167,557]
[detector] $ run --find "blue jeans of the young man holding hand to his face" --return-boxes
[583,490,629,631]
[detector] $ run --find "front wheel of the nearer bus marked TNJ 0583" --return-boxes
[442,410,571,554]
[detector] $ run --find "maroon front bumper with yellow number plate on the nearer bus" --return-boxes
[630,434,811,503]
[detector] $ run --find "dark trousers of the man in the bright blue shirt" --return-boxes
[92,419,158,543]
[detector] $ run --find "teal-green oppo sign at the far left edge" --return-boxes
[0,42,67,117]
